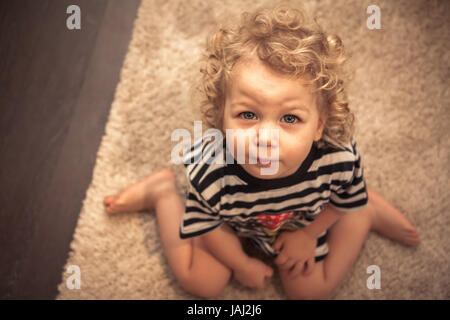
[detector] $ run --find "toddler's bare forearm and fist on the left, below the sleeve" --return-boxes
[202,223,273,288]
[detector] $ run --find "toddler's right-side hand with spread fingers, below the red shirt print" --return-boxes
[274,229,317,278]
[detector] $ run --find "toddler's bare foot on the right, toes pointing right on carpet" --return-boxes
[367,189,420,246]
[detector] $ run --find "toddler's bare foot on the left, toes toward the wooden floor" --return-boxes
[103,169,176,214]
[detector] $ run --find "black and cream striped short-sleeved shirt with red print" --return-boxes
[180,138,368,256]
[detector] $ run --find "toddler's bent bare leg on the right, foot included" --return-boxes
[280,189,419,299]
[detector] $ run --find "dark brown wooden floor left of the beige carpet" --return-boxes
[0,0,139,299]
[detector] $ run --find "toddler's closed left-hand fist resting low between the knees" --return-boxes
[234,257,273,289]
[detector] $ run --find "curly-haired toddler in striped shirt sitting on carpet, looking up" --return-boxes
[104,5,419,299]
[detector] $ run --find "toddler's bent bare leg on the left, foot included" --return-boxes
[104,170,231,298]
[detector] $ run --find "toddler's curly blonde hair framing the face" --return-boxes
[199,3,354,147]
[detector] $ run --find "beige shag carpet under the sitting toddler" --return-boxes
[58,0,450,299]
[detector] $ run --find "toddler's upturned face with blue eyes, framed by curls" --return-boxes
[223,58,324,179]
